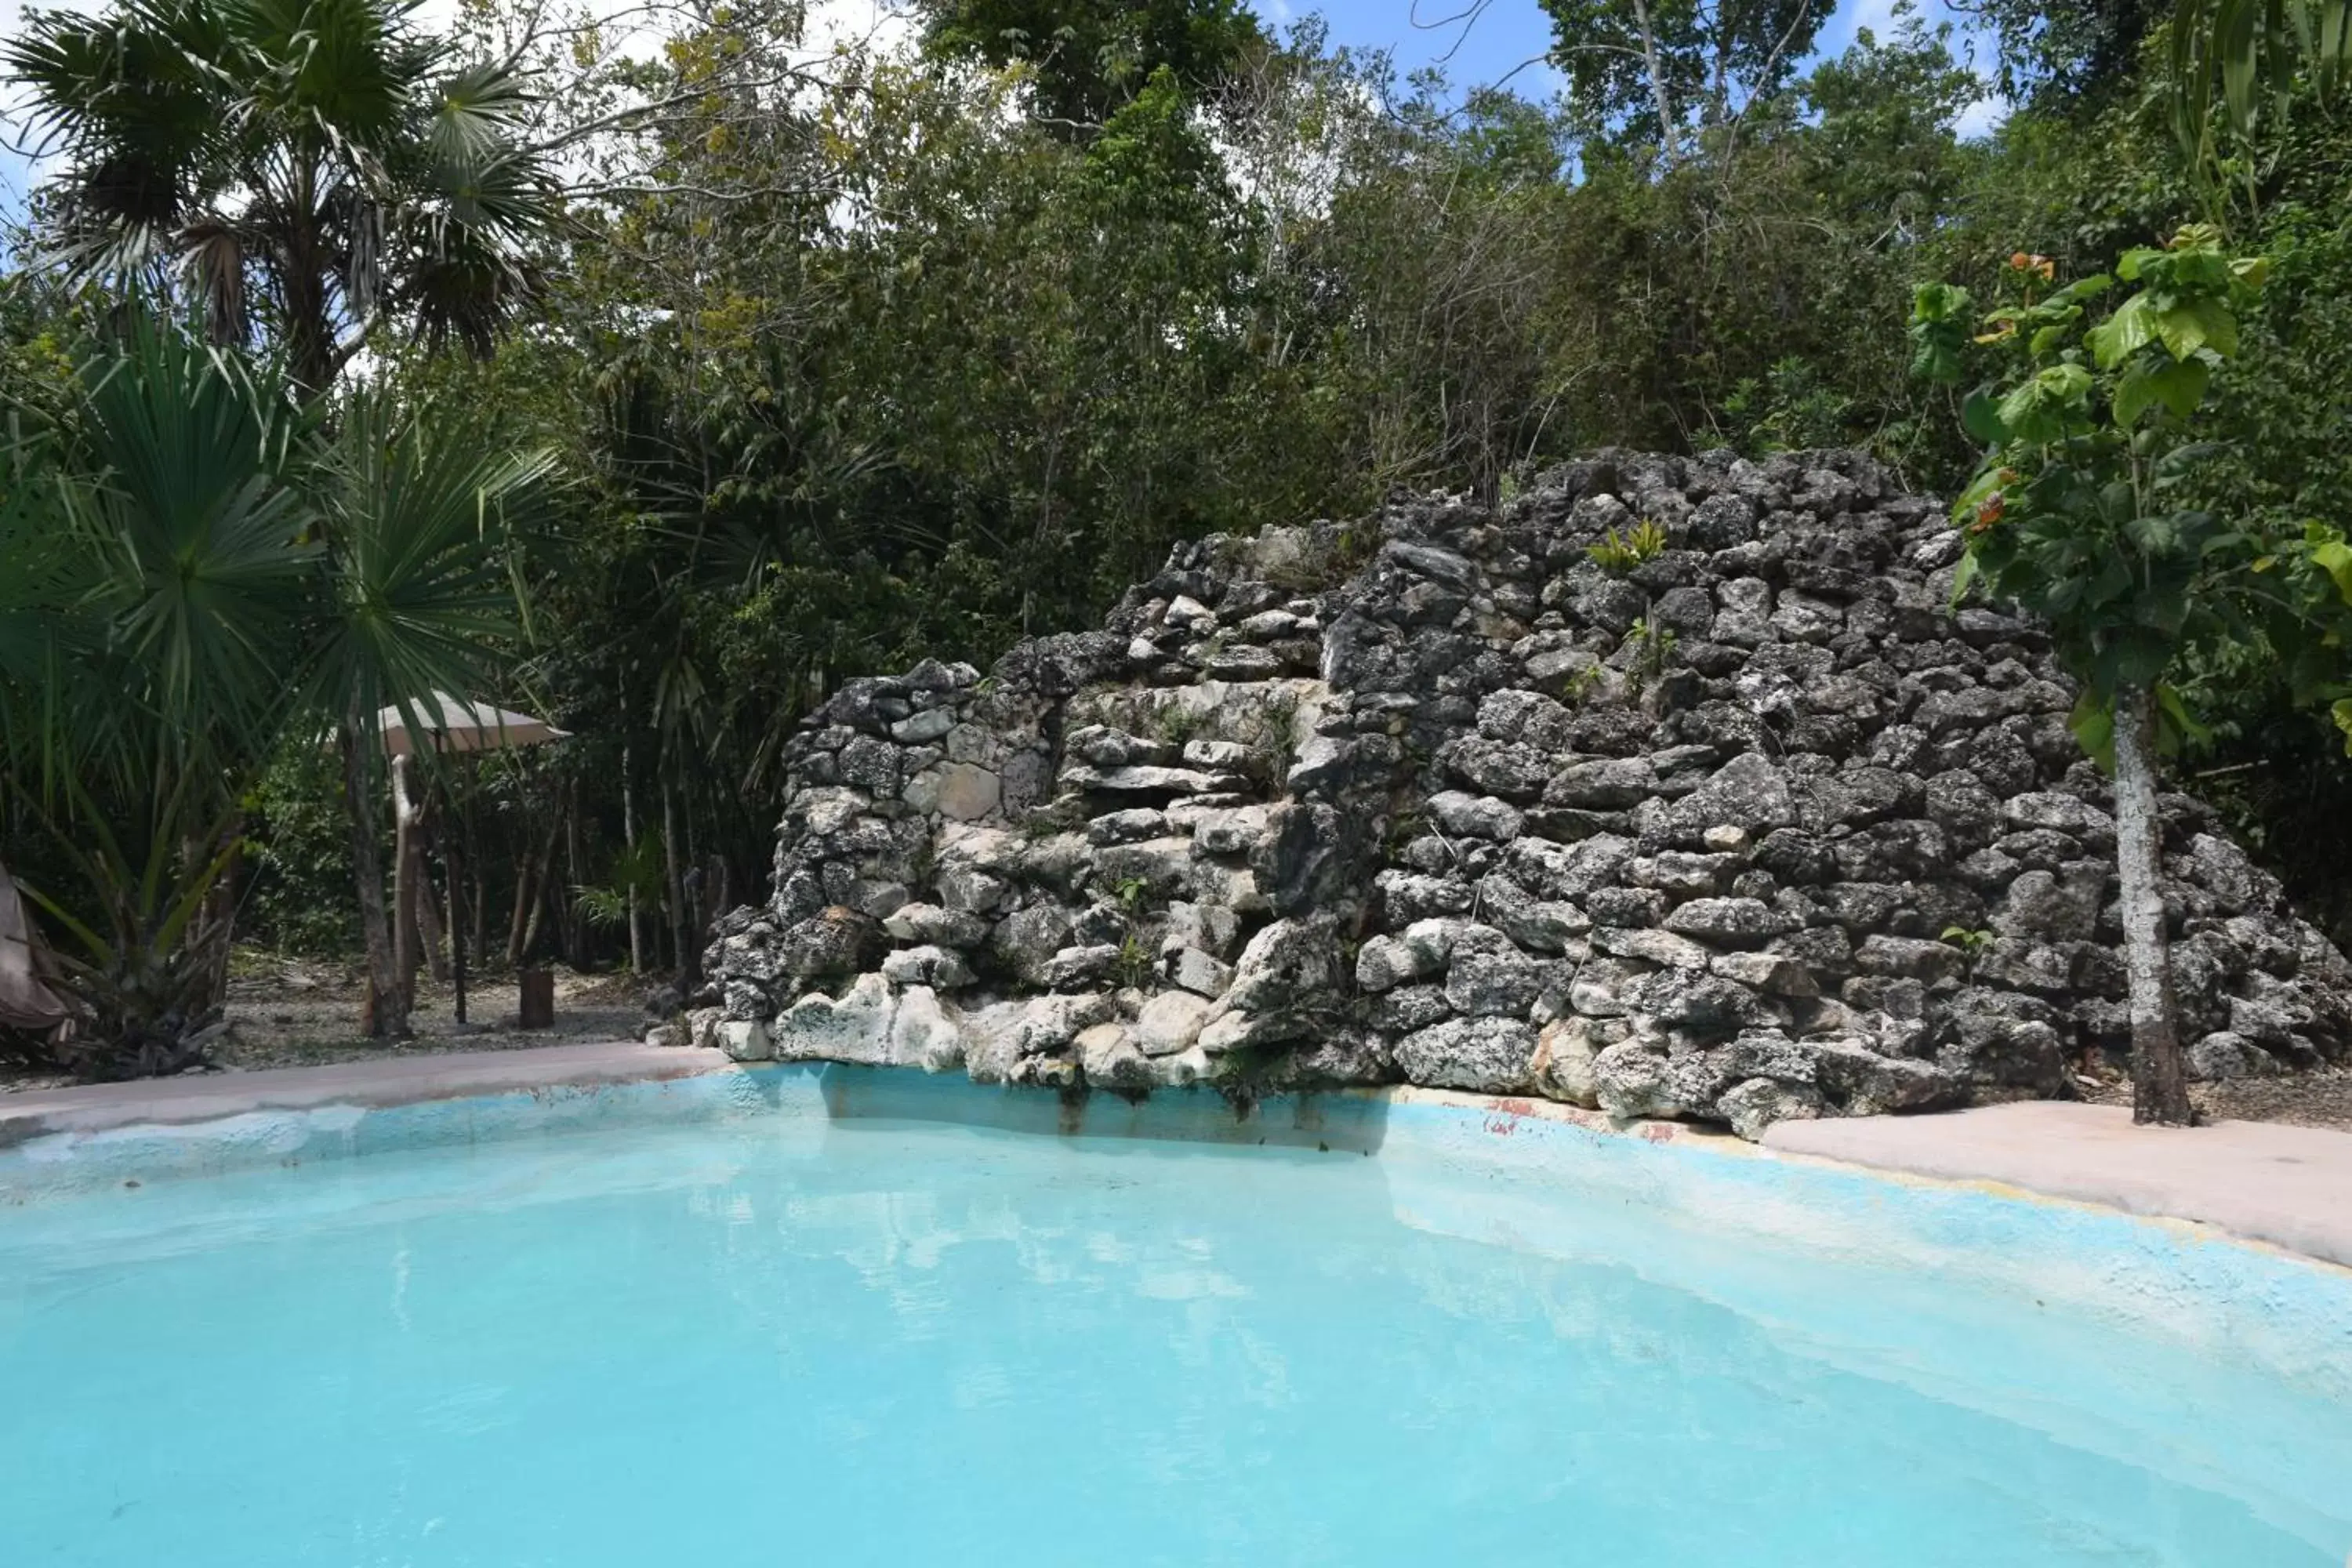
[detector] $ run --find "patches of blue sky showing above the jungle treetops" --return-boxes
[0,0,2002,214]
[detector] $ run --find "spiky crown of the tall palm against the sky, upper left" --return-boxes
[0,0,560,400]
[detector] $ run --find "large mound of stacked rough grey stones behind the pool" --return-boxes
[682,452,2352,1135]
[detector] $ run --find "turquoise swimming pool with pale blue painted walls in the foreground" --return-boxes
[0,1081,2352,1568]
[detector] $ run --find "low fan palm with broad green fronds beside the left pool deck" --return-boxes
[0,318,546,1076]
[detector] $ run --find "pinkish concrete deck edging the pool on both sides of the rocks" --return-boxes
[0,1041,2352,1267]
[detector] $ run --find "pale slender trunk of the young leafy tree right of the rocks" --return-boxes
[2114,687,2192,1126]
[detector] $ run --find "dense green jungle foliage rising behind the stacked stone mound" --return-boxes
[0,0,2352,1072]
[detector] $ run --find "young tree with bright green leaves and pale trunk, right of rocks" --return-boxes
[1910,226,2352,1123]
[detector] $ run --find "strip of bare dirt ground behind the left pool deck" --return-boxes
[0,949,661,1093]
